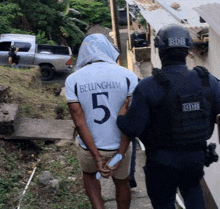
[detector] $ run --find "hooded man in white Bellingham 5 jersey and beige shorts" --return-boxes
[65,34,138,209]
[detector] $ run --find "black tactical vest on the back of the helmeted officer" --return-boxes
[141,67,214,150]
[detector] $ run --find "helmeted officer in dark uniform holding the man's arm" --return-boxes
[117,25,220,209]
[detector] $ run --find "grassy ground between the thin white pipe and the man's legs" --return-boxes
[18,145,92,209]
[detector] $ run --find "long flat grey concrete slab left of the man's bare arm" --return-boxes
[0,118,74,141]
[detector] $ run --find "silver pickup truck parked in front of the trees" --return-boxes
[0,34,73,80]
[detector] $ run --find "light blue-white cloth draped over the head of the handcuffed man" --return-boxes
[74,33,119,71]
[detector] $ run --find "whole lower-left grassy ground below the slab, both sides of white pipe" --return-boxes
[0,140,92,209]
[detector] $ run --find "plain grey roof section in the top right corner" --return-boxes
[194,1,220,35]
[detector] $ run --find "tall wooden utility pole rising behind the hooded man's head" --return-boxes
[110,0,121,65]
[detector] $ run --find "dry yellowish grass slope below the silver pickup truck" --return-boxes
[0,67,70,119]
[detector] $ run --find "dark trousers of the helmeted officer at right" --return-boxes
[144,161,205,209]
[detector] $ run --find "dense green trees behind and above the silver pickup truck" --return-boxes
[0,0,111,48]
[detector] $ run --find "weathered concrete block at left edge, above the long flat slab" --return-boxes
[0,103,19,134]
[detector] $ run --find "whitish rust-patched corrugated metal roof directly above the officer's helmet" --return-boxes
[126,0,217,38]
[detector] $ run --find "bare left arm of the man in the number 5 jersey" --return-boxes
[68,103,101,161]
